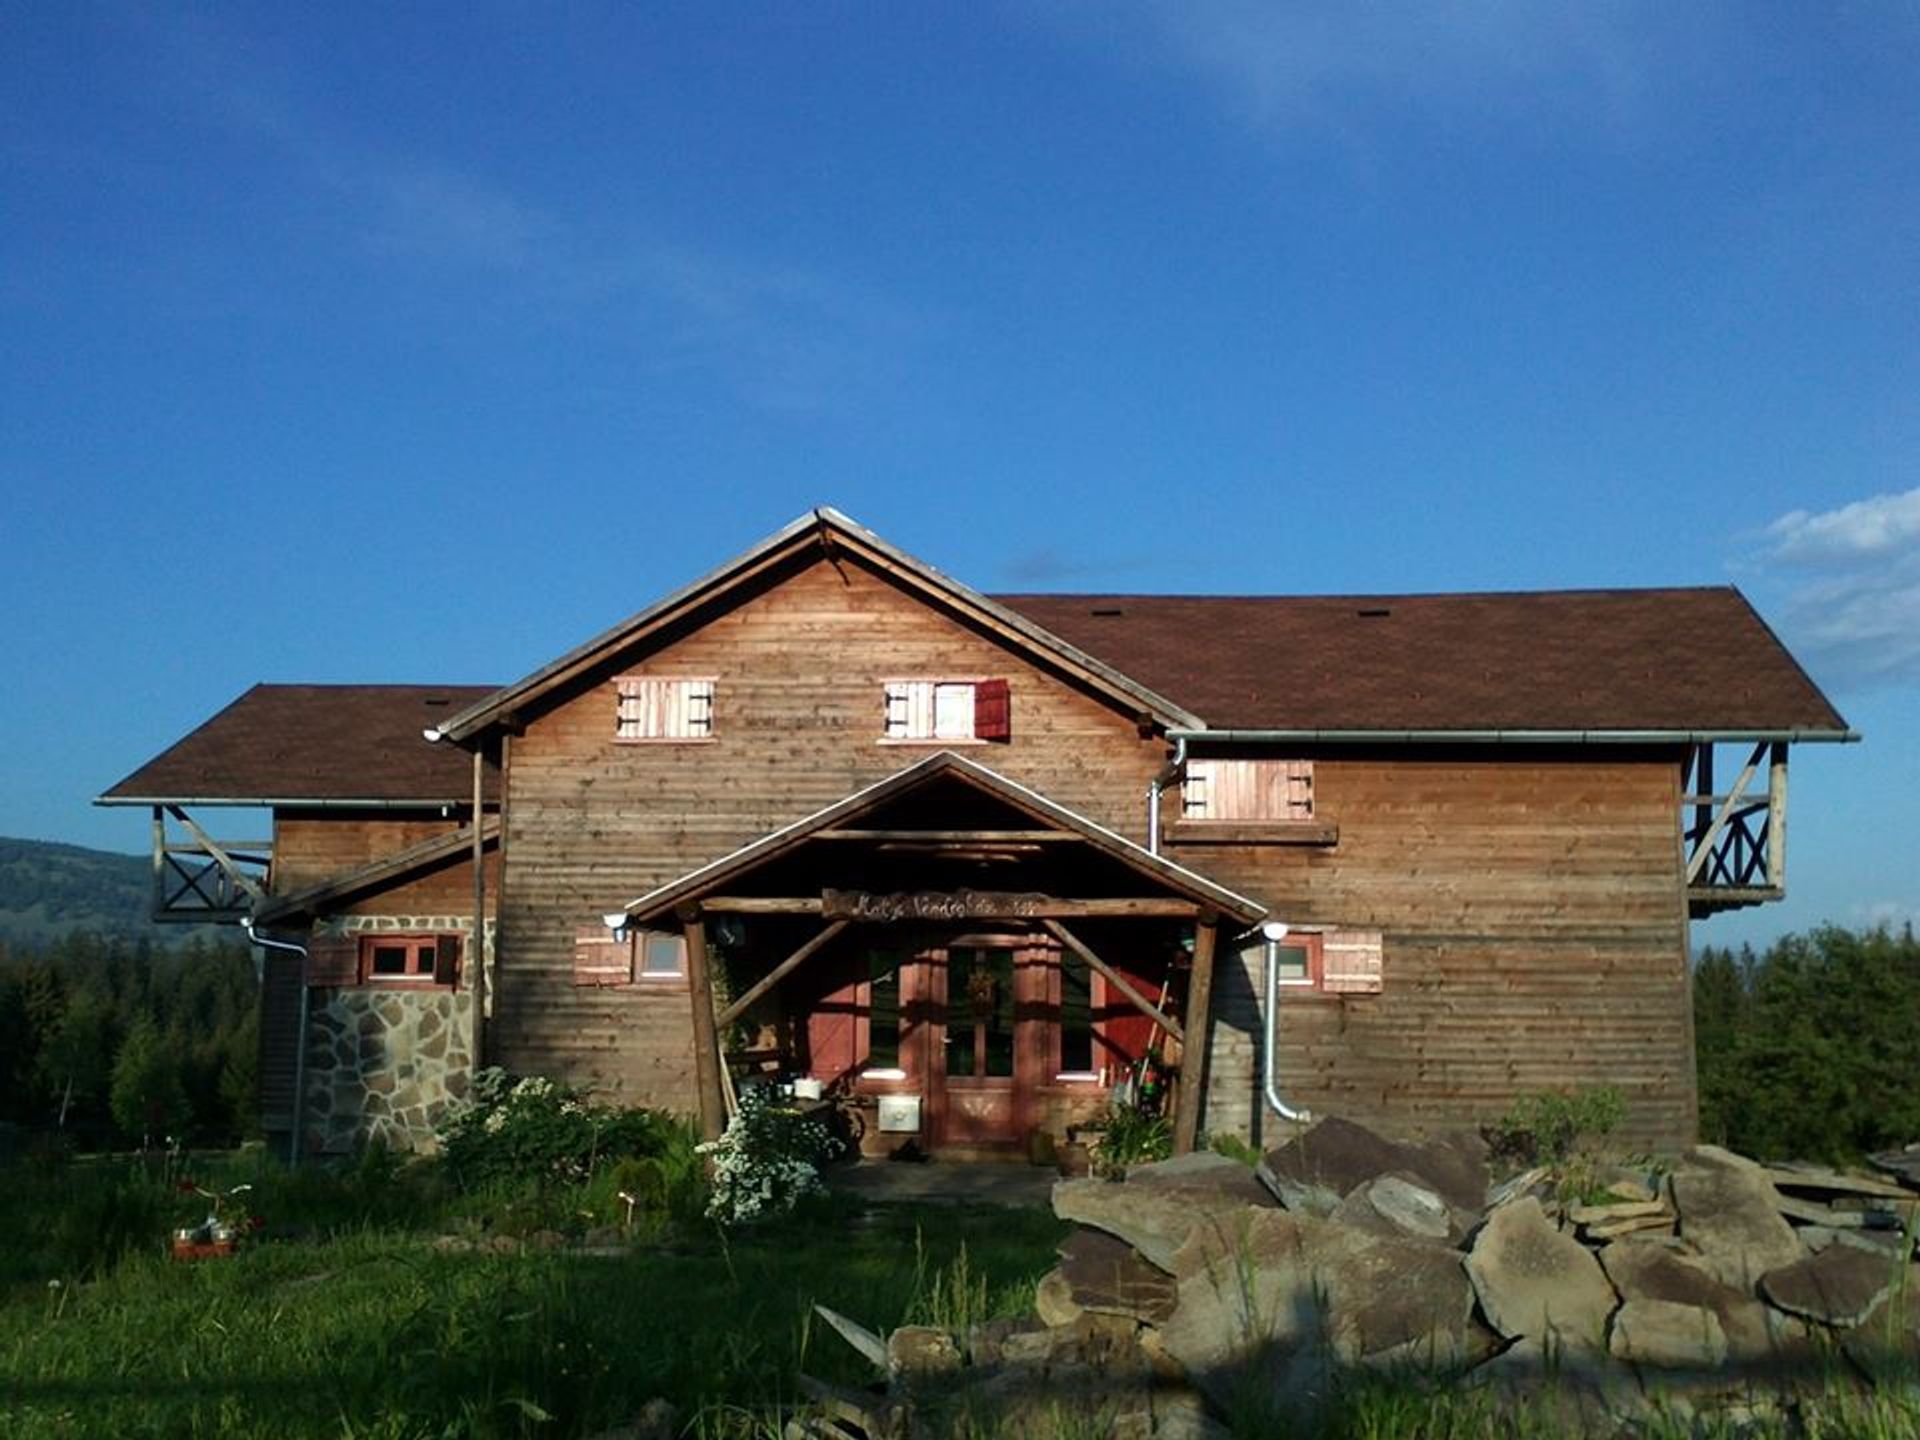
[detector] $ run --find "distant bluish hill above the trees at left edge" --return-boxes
[0,837,228,945]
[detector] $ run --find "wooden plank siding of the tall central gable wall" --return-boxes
[488,557,1164,1110]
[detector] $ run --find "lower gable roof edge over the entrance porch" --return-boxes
[626,751,1267,924]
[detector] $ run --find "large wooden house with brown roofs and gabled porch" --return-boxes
[102,509,1853,1156]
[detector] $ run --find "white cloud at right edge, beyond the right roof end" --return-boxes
[1757,488,1920,689]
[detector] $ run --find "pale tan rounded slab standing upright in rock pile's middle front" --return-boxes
[1467,1196,1615,1350]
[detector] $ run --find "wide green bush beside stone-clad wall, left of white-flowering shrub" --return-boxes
[436,1068,687,1190]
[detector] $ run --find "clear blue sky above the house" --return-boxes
[0,0,1920,941]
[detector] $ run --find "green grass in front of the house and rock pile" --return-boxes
[0,1158,1920,1440]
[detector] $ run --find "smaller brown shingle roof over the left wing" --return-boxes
[100,685,493,804]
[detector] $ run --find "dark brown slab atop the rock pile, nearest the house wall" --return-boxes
[1258,1116,1486,1215]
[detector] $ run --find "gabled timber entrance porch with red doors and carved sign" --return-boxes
[606,753,1265,1160]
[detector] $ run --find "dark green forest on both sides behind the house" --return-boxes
[0,925,1920,1160]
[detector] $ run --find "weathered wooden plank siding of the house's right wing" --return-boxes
[1169,751,1695,1146]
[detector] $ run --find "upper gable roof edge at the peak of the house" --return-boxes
[440,507,1200,741]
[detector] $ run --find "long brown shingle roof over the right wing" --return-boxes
[995,586,1845,733]
